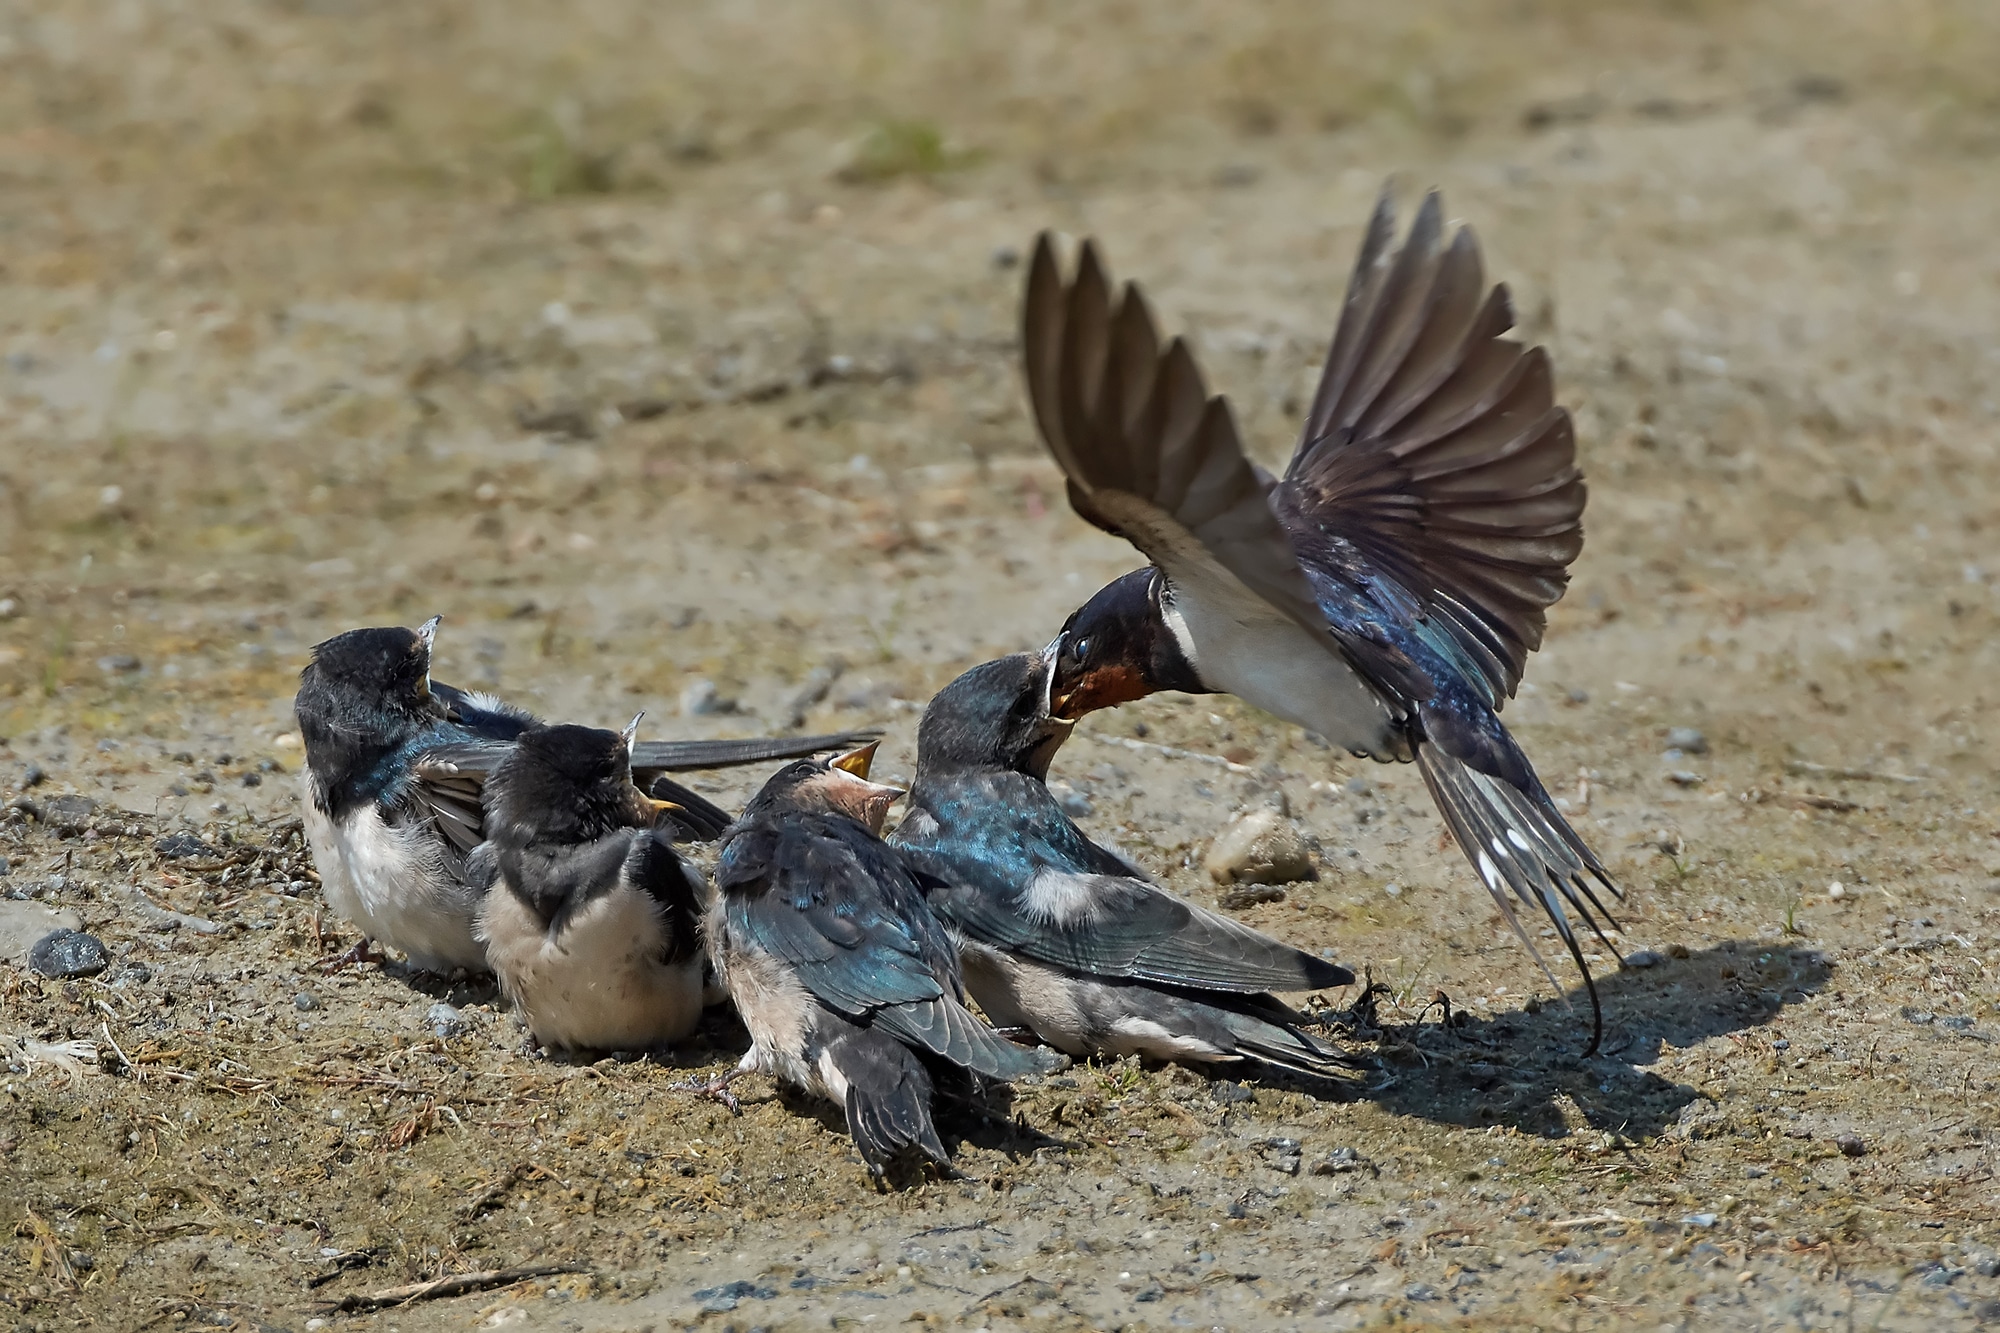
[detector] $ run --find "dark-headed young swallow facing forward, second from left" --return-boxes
[466,719,708,1051]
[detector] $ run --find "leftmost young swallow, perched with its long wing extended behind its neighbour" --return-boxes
[294,616,876,973]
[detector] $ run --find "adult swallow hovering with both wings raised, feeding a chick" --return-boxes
[1022,194,1618,1051]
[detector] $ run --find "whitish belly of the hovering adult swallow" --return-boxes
[1174,578,1400,761]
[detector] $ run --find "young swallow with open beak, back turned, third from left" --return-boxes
[702,745,1044,1179]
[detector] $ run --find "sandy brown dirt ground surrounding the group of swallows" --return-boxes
[0,0,2000,1333]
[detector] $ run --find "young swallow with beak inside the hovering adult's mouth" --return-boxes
[890,644,1354,1077]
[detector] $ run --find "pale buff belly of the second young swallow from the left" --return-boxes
[480,885,702,1051]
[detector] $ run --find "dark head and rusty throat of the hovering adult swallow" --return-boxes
[1050,566,1208,721]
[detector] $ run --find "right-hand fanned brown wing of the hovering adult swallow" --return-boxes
[1278,194,1586,705]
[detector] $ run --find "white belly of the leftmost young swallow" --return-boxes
[302,793,486,973]
